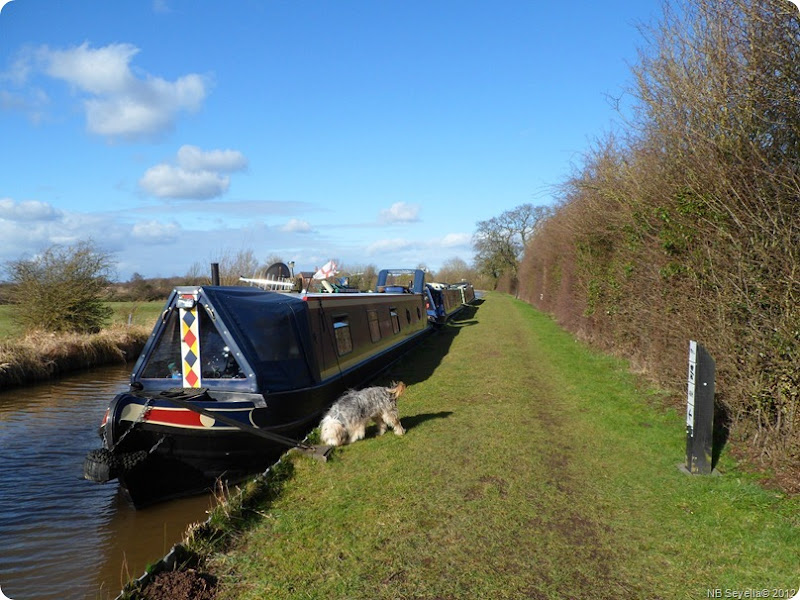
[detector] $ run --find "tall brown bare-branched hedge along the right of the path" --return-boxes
[520,0,800,478]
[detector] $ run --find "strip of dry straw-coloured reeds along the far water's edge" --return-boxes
[0,325,150,390]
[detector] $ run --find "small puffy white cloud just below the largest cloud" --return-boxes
[139,146,247,200]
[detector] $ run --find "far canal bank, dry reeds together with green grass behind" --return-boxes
[0,302,163,389]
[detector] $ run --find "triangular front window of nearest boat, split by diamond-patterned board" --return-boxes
[142,307,245,380]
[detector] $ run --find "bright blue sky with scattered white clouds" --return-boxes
[0,0,660,280]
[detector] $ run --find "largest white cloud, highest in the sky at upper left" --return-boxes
[20,42,208,141]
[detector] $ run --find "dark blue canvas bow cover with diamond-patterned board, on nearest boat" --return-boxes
[132,286,318,393]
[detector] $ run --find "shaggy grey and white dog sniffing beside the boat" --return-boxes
[320,381,406,446]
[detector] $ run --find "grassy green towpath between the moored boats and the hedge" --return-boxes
[207,294,800,600]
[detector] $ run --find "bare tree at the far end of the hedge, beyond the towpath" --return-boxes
[473,204,550,287]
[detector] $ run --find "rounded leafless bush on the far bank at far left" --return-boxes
[6,241,113,333]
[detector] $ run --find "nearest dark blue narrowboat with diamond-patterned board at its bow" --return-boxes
[84,269,432,507]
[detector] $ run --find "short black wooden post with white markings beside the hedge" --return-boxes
[685,341,716,475]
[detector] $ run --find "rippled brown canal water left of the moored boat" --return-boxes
[0,367,213,600]
